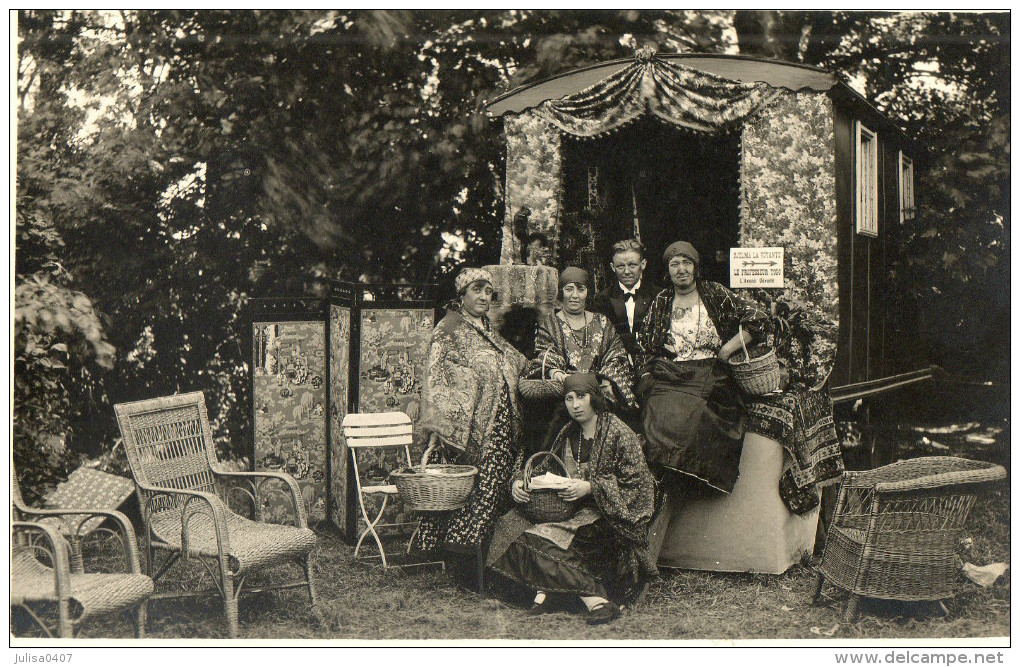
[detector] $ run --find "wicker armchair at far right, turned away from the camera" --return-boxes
[814,456,1006,623]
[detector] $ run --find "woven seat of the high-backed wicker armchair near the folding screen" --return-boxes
[152,510,316,573]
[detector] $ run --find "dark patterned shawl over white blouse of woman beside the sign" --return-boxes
[635,280,772,368]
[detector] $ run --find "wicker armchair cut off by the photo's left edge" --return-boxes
[10,475,153,637]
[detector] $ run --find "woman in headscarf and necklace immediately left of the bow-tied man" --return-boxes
[526,266,634,416]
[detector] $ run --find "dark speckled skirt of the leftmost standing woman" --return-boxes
[411,388,521,555]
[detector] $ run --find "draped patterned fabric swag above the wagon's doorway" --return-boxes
[536,56,780,137]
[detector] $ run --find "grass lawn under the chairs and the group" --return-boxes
[12,426,1010,642]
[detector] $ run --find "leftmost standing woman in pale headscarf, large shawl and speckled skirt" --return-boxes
[412,268,527,567]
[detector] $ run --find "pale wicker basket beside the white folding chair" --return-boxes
[390,433,478,512]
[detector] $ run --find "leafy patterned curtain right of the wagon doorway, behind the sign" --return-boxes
[741,93,839,388]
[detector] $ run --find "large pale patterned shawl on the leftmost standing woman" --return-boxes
[416,310,527,461]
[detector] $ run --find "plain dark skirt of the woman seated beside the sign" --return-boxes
[638,359,746,494]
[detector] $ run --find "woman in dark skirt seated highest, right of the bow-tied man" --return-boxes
[636,241,770,557]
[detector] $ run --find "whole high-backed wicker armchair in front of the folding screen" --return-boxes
[114,392,316,637]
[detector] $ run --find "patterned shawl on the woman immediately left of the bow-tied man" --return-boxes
[525,311,634,408]
